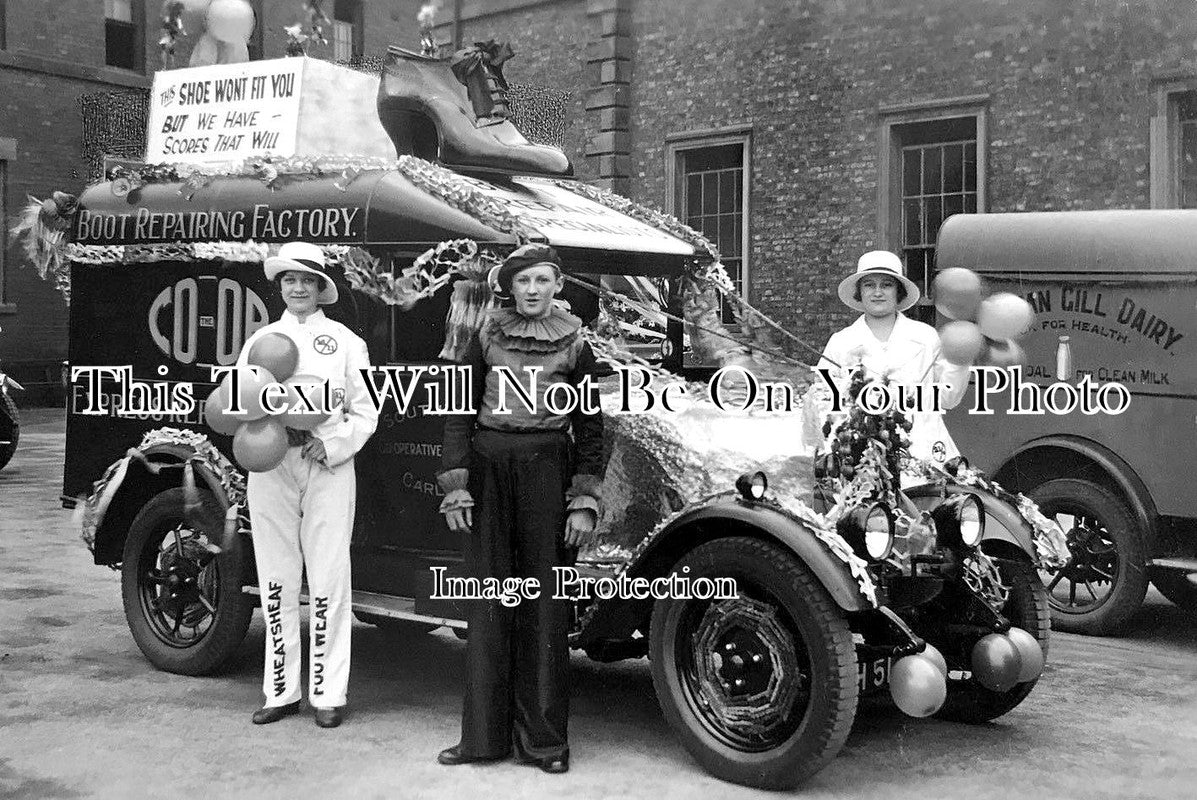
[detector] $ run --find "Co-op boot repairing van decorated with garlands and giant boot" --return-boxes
[28,49,1058,788]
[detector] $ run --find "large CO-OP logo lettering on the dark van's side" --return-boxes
[147,275,268,366]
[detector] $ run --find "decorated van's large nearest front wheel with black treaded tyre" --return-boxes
[649,538,858,789]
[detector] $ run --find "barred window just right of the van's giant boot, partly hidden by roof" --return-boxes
[667,131,752,322]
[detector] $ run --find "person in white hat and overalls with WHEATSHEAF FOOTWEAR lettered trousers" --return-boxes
[238,242,378,728]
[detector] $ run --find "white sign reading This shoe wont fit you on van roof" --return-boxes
[146,59,306,164]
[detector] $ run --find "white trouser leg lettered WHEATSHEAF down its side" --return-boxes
[245,448,303,705]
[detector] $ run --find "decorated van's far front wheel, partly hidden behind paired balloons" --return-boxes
[937,559,1051,722]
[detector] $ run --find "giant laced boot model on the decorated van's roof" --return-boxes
[378,47,573,175]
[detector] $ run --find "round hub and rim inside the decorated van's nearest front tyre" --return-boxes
[679,595,810,752]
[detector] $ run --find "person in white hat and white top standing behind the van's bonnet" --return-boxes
[819,250,968,463]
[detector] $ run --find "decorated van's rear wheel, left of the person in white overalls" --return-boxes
[121,489,254,675]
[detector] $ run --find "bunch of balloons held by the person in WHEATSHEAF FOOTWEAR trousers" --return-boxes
[203,333,329,472]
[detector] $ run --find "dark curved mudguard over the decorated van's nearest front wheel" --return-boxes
[578,493,879,647]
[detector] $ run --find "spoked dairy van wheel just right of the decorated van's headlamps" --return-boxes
[1031,478,1147,636]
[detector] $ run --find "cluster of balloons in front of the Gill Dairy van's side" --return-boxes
[935,267,1034,366]
